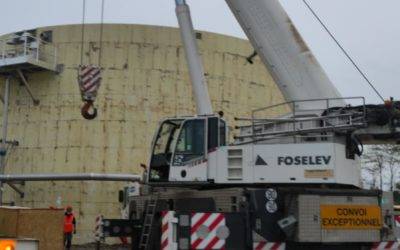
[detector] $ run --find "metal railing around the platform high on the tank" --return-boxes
[0,33,57,68]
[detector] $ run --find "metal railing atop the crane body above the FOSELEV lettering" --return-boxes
[235,97,367,143]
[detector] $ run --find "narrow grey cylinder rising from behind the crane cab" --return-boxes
[175,0,213,115]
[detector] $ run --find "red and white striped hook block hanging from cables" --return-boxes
[78,65,101,94]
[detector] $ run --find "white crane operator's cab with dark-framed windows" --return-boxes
[148,116,227,184]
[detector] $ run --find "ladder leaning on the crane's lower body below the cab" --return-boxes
[139,194,158,250]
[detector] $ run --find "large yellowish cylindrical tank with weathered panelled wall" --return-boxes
[0,24,283,243]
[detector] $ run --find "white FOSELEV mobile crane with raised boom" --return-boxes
[102,0,400,250]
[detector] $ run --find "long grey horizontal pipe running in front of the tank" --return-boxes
[0,173,142,182]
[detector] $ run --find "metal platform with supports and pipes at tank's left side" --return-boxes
[0,30,60,205]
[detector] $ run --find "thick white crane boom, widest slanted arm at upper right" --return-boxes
[226,0,343,109]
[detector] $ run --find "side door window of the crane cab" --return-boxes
[173,119,205,166]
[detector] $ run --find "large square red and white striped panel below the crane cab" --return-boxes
[190,213,225,250]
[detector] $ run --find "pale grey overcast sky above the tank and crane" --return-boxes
[0,0,400,103]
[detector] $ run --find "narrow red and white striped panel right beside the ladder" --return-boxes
[161,211,177,250]
